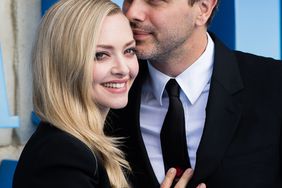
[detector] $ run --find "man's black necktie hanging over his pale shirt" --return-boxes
[160,79,191,181]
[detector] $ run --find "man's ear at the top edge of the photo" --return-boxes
[195,0,217,25]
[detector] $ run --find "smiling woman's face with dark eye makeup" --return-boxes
[92,13,138,110]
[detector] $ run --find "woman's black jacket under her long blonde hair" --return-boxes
[13,123,110,188]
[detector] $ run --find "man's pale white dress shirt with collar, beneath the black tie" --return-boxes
[140,33,214,182]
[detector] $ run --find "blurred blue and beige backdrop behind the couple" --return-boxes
[0,0,282,187]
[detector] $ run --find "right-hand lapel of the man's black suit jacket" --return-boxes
[191,34,243,184]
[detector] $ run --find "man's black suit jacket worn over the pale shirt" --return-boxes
[107,36,282,188]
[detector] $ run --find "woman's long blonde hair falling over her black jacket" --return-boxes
[32,0,129,187]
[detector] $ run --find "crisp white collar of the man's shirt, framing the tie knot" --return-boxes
[148,33,214,105]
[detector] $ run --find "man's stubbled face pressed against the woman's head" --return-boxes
[123,0,200,60]
